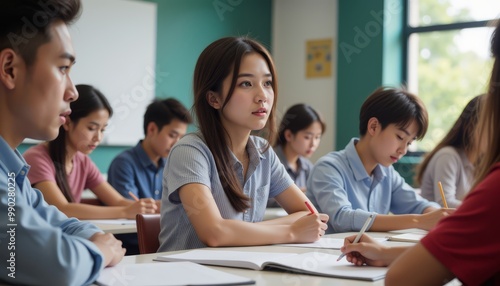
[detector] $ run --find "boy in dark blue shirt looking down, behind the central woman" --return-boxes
[108,98,192,206]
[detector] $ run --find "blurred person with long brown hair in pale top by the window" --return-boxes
[416,96,483,208]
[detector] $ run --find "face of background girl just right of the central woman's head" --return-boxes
[285,121,323,158]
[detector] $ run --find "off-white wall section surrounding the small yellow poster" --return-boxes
[272,0,338,162]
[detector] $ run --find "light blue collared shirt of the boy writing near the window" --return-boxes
[306,138,440,233]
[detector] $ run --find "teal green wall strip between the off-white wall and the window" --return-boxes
[336,0,403,150]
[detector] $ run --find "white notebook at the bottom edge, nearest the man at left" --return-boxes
[96,262,255,286]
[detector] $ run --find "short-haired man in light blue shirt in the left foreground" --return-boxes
[0,0,125,285]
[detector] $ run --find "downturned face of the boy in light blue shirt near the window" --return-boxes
[368,121,418,167]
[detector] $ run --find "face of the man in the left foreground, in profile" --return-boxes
[12,21,78,140]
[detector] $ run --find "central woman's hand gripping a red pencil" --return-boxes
[291,213,328,243]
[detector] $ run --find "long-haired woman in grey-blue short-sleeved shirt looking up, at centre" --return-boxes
[159,37,328,251]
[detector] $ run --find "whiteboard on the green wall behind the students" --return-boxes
[69,0,157,146]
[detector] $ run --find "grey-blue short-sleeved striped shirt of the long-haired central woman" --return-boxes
[158,133,293,251]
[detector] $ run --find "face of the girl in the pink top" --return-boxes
[64,109,109,155]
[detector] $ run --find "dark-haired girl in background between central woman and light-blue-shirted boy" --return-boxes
[268,104,326,207]
